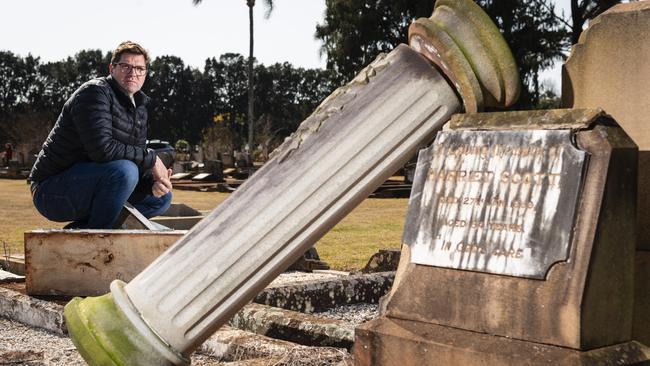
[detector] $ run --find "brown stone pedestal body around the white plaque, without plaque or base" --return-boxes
[374,113,637,350]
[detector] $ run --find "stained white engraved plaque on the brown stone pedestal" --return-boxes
[403,130,586,279]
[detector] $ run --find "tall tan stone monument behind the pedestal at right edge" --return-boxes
[562,1,650,250]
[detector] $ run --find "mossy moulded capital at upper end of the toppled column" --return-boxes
[409,0,520,113]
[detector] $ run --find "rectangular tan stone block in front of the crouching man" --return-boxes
[25,230,185,296]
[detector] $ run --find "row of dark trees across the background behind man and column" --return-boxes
[0,0,620,163]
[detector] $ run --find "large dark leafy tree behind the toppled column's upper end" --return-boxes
[316,0,566,108]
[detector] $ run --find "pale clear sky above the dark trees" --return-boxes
[0,0,570,89]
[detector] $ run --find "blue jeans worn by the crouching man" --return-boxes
[34,160,172,229]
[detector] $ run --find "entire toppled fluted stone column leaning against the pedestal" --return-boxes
[60,0,519,365]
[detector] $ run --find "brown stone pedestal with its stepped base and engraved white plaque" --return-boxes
[355,110,650,366]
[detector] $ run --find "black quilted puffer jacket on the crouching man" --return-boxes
[29,76,156,182]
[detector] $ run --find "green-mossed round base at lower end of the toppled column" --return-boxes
[64,280,190,366]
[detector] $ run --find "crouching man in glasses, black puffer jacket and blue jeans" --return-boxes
[29,41,172,229]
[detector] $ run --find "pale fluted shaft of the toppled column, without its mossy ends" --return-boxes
[113,45,462,355]
